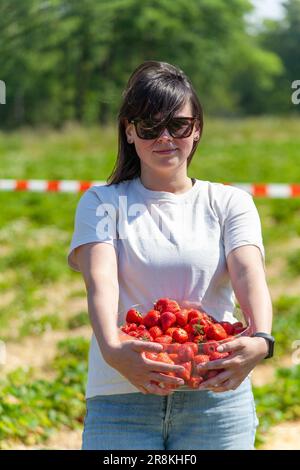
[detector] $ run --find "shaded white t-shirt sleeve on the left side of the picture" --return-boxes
[67,187,117,272]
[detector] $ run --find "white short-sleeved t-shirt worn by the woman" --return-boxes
[68,178,264,398]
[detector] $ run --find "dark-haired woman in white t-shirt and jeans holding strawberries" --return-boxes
[68,61,272,450]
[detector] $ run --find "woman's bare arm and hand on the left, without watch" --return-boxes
[75,243,182,395]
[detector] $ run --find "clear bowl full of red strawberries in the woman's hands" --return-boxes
[120,297,251,390]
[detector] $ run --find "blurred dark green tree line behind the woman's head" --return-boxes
[0,0,300,128]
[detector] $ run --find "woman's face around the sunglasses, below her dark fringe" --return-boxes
[126,102,200,172]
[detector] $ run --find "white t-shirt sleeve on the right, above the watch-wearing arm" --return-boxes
[223,188,265,262]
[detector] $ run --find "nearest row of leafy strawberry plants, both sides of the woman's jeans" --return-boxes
[0,337,300,449]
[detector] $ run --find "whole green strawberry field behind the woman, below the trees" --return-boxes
[0,117,300,449]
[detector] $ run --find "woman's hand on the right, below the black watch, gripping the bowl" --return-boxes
[198,336,268,392]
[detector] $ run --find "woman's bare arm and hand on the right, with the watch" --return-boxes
[199,245,272,392]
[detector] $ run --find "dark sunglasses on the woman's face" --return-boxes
[130,117,198,140]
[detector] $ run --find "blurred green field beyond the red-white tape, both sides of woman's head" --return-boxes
[0,117,300,183]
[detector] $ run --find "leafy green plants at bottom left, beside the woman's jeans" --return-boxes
[0,337,89,449]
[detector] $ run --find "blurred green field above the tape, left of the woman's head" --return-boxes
[0,124,117,180]
